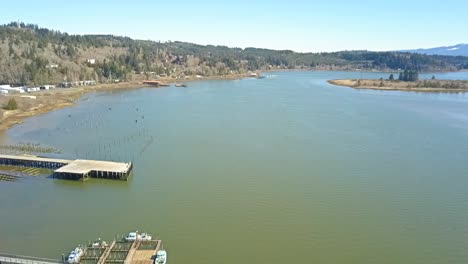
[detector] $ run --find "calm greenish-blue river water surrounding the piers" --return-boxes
[0,72,468,264]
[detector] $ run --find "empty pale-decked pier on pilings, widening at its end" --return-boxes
[0,155,133,181]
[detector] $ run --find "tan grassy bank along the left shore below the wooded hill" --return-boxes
[0,74,252,131]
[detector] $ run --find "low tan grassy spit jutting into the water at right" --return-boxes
[328,79,468,93]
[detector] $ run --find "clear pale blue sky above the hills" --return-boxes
[0,0,468,52]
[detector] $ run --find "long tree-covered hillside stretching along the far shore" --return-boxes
[0,22,468,84]
